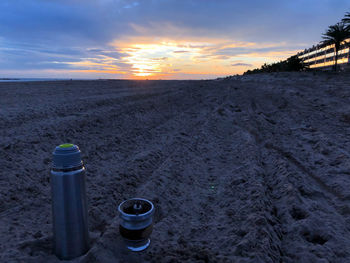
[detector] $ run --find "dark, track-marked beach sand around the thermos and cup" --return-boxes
[0,73,350,262]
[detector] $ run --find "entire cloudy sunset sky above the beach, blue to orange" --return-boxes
[0,0,350,79]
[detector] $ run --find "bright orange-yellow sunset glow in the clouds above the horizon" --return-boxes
[47,35,304,79]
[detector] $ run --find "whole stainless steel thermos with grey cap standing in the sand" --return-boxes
[51,144,89,259]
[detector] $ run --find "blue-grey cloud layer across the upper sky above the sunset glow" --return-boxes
[0,0,350,44]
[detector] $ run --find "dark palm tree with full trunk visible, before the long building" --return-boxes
[322,23,350,71]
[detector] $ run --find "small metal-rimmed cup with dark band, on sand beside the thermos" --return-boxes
[118,198,154,251]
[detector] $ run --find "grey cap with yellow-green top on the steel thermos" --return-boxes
[52,143,83,169]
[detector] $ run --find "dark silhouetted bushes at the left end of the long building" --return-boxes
[244,55,305,74]
